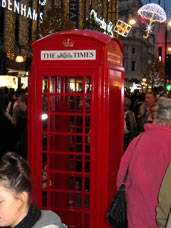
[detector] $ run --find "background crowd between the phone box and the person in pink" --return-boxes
[124,91,169,151]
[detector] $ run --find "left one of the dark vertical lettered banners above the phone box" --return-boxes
[69,0,79,28]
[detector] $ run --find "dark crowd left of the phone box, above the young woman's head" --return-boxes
[0,87,27,159]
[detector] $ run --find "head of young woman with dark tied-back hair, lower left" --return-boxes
[0,152,32,227]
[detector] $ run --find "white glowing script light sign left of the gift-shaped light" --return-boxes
[90,10,113,36]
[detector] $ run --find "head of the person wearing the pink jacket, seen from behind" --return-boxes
[154,97,171,127]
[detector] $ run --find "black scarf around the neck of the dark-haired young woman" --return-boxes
[14,204,41,228]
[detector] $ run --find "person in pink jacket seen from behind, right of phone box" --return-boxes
[117,98,171,228]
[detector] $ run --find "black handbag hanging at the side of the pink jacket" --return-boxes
[107,169,128,228]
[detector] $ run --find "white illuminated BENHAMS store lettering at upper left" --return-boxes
[0,0,46,22]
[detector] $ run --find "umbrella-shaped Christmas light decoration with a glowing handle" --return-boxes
[138,3,167,39]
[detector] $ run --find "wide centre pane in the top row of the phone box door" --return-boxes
[50,76,83,93]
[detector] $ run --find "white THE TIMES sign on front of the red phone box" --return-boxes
[41,50,96,60]
